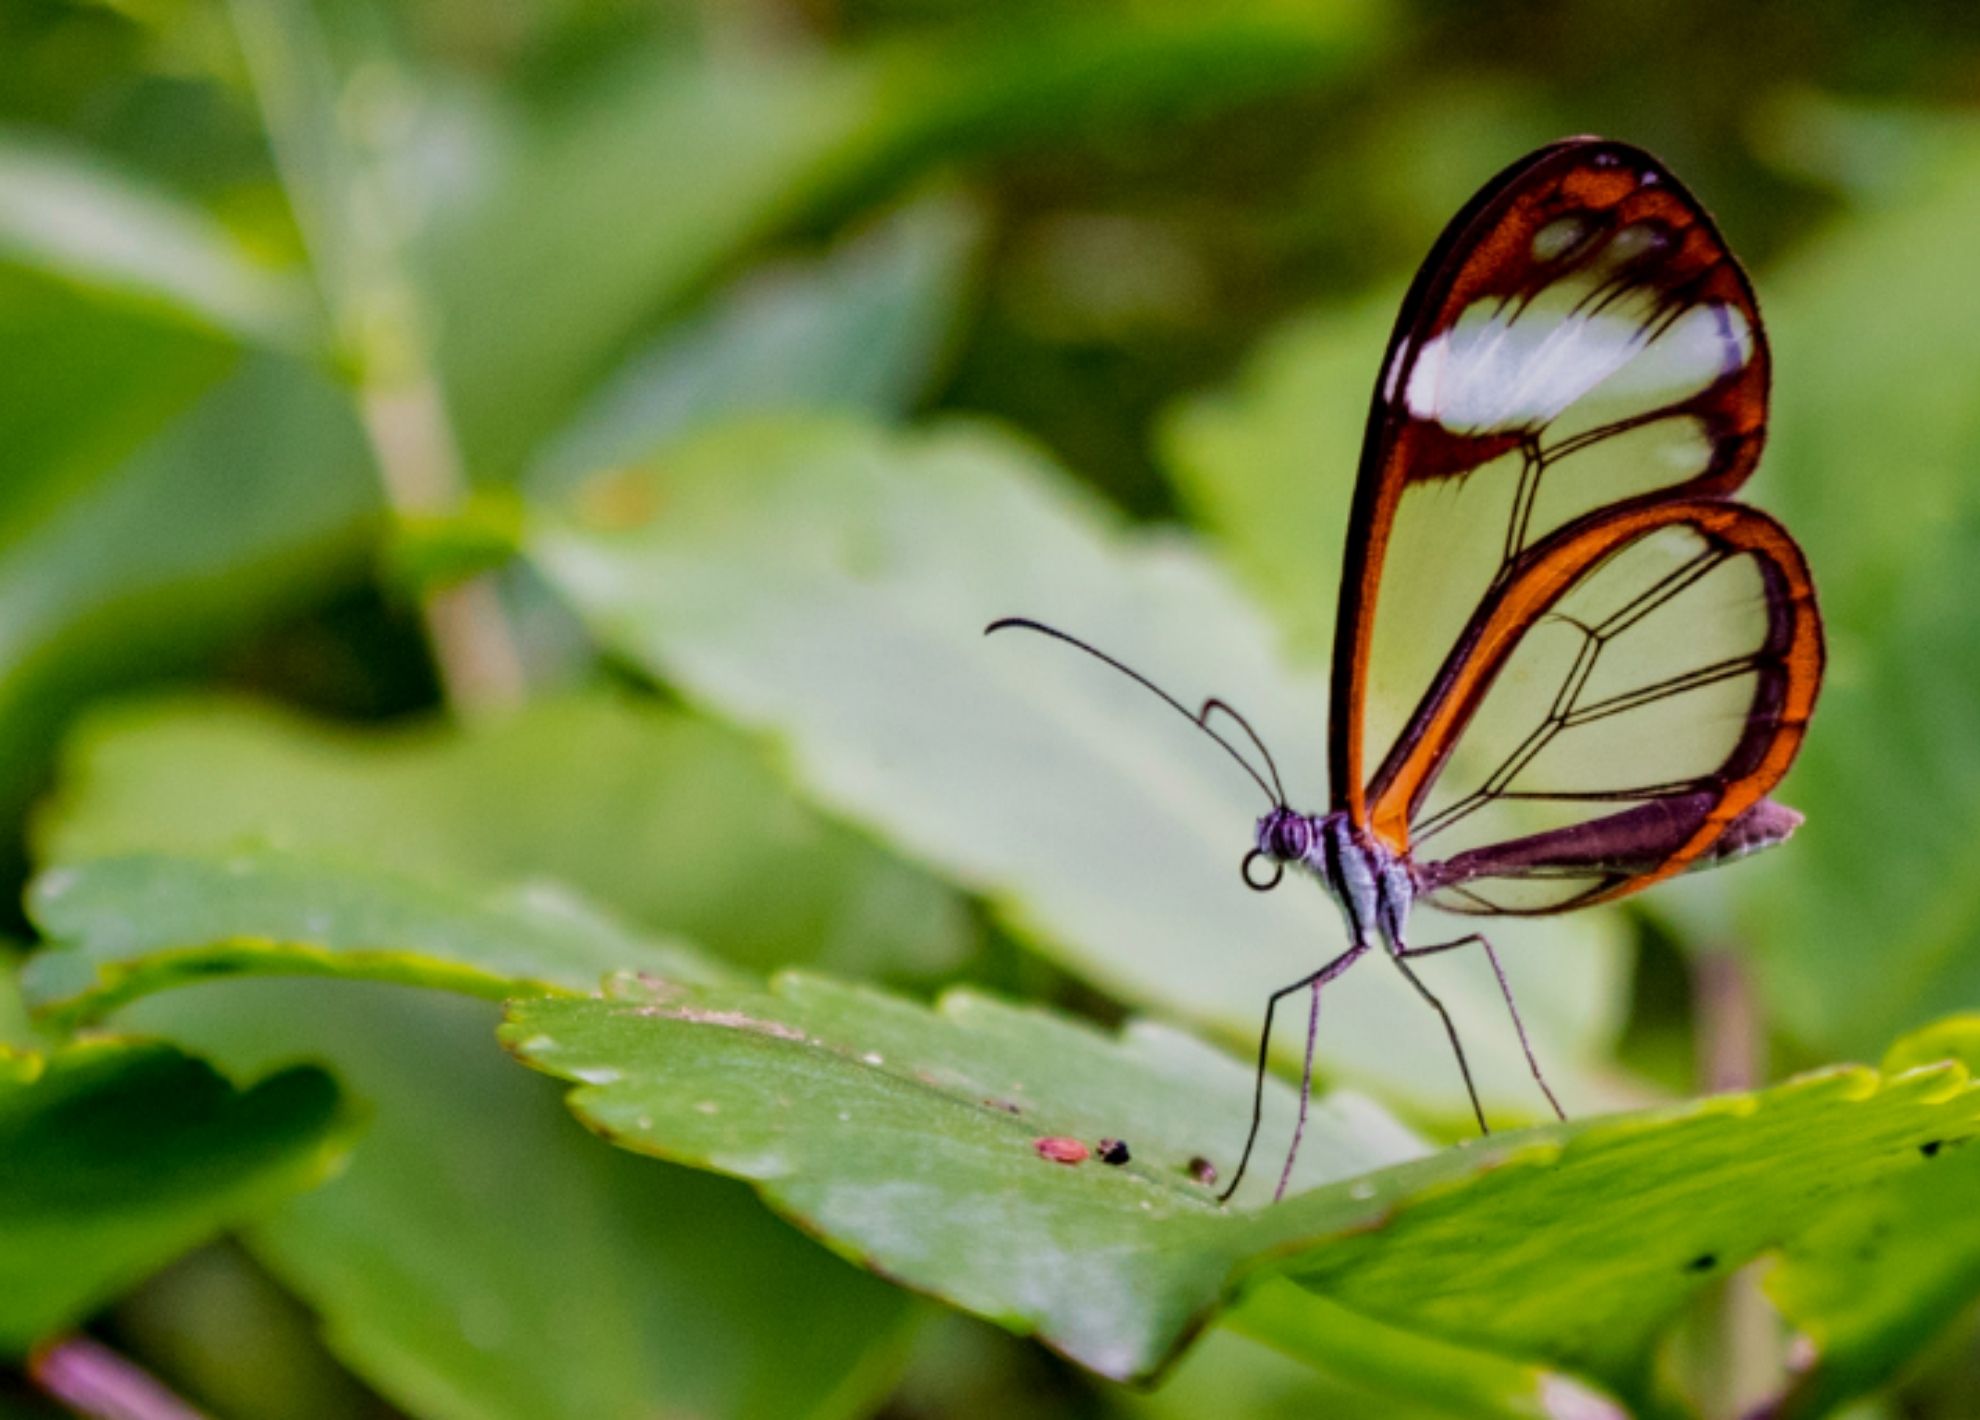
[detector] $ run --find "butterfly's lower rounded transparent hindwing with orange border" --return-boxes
[1372,499,1822,913]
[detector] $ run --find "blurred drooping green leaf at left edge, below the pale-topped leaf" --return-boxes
[0,356,376,831]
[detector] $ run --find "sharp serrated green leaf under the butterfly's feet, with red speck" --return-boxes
[503,976,1980,1414]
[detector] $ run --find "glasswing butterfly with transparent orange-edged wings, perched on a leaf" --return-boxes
[988,139,1824,1198]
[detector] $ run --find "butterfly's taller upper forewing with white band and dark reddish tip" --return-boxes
[1331,141,1768,850]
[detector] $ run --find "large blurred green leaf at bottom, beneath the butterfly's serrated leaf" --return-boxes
[133,980,919,1420]
